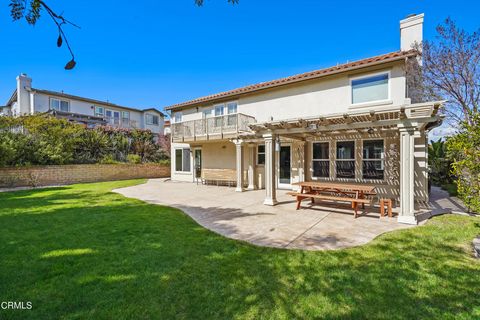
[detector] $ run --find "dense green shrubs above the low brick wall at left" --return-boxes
[0,114,168,166]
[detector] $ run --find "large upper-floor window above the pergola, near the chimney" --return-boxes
[352,73,389,104]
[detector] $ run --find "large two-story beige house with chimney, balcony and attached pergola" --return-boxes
[166,14,443,224]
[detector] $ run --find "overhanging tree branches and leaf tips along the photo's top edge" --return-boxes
[9,0,239,70]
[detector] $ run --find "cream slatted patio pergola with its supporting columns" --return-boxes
[232,101,445,223]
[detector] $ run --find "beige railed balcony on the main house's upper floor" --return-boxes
[172,113,255,142]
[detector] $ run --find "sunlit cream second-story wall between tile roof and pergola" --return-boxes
[172,61,408,122]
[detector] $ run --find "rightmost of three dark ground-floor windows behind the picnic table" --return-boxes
[362,140,385,180]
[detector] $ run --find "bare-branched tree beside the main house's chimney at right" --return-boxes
[409,18,480,124]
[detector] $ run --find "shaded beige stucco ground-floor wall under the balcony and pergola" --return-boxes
[172,131,428,205]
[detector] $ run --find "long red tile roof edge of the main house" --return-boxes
[165,50,417,110]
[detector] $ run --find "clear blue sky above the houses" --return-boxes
[0,0,480,115]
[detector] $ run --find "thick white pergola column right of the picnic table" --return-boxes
[398,126,417,224]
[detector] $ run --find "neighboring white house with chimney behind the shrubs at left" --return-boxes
[3,74,164,134]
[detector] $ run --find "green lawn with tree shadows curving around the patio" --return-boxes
[0,181,480,319]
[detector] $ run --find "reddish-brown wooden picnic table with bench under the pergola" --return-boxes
[287,181,376,218]
